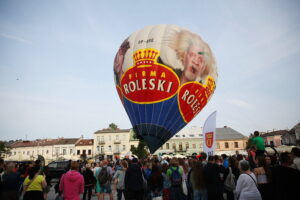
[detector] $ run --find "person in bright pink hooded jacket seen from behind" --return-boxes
[59,161,84,200]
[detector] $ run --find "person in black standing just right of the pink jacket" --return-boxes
[82,164,95,200]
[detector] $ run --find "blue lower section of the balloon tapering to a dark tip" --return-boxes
[124,95,186,153]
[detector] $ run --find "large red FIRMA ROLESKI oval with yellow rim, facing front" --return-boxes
[121,63,179,103]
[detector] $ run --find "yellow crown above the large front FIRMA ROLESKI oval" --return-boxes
[133,48,159,66]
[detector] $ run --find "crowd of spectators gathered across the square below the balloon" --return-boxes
[0,132,300,200]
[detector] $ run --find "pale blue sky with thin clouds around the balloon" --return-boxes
[0,0,300,140]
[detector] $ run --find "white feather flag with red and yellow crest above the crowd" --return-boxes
[203,111,217,156]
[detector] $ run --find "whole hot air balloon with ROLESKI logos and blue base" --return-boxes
[114,25,218,153]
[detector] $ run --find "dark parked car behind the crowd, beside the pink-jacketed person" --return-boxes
[45,160,69,179]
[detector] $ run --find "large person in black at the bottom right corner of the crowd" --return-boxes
[272,152,300,200]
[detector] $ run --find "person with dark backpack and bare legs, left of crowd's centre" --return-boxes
[95,160,113,200]
